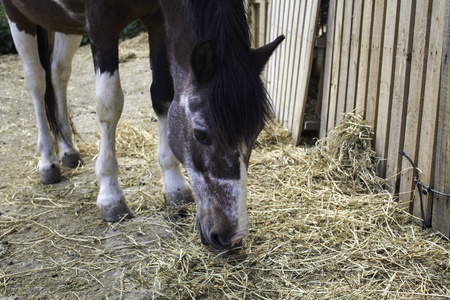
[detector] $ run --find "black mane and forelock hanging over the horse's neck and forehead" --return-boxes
[185,0,271,147]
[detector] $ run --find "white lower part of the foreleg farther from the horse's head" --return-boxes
[95,70,124,206]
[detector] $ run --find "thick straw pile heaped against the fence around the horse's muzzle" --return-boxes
[142,114,450,299]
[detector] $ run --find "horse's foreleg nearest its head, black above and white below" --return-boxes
[142,11,194,206]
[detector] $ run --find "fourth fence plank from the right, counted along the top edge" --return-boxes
[375,1,401,177]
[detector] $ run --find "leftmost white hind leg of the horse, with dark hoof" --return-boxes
[9,21,61,184]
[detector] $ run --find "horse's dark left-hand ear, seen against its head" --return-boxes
[191,40,217,84]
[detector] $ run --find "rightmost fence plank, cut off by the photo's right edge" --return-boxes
[431,0,450,238]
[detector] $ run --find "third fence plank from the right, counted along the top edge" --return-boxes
[386,0,415,193]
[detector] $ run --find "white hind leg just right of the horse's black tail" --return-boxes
[51,33,81,168]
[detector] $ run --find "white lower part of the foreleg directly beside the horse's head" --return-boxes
[158,117,190,194]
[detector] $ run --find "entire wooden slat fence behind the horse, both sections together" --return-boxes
[248,0,450,237]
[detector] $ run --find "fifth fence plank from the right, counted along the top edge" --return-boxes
[366,0,385,139]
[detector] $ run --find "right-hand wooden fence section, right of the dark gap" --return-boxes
[321,0,450,237]
